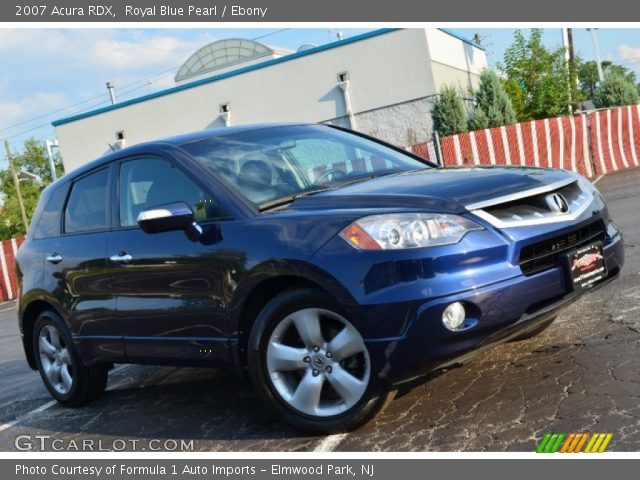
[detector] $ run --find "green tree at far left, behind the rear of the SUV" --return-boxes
[0,138,64,239]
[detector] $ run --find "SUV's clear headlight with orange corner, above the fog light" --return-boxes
[340,213,482,250]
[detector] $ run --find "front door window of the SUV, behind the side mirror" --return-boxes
[119,158,226,227]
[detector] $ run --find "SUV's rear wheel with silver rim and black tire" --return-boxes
[33,311,109,407]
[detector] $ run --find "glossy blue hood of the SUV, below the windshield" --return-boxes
[290,167,571,213]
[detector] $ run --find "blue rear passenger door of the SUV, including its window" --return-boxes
[44,166,123,360]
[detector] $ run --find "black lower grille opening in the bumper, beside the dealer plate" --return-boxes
[519,220,605,276]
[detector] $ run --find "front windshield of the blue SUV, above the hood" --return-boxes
[182,125,430,210]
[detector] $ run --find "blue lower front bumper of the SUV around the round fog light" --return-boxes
[367,227,624,383]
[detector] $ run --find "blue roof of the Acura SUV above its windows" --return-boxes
[58,122,317,185]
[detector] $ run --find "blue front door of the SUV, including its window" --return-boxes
[107,155,228,363]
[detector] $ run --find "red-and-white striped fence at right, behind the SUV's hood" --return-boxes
[430,105,640,177]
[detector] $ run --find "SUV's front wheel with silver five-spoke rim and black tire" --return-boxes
[248,288,389,434]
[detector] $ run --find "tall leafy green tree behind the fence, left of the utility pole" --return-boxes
[499,29,571,122]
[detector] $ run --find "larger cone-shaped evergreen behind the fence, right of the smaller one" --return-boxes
[471,69,516,130]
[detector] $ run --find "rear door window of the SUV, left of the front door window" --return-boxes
[64,168,109,233]
